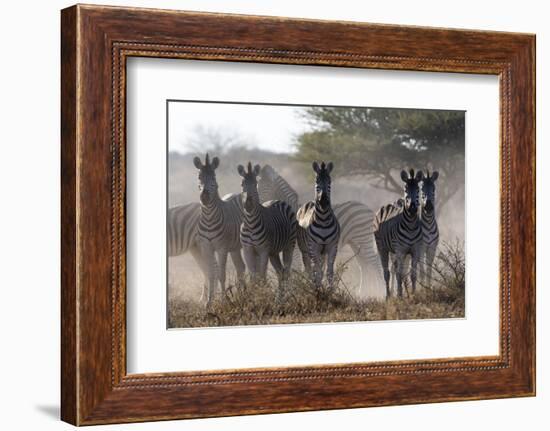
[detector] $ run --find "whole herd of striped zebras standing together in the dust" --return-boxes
[167,154,439,306]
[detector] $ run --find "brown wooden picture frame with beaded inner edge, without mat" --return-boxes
[61,5,535,425]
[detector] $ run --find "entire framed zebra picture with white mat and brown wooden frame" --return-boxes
[61,5,535,425]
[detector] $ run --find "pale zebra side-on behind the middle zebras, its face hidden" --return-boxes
[258,165,379,292]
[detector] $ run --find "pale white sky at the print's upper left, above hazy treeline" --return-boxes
[168,101,310,153]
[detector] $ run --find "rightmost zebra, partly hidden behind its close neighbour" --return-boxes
[420,171,439,286]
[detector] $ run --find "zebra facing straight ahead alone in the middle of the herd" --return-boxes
[296,162,340,291]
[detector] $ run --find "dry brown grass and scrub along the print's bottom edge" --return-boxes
[168,243,465,328]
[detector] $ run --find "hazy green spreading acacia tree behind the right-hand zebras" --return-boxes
[296,107,465,215]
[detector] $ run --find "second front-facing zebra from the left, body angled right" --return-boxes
[237,162,296,294]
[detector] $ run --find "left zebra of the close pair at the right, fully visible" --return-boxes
[374,169,423,298]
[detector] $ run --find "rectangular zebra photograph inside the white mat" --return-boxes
[166,100,466,328]
